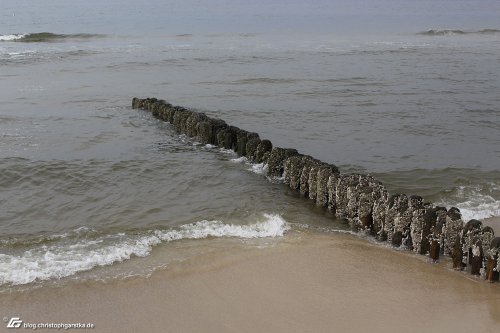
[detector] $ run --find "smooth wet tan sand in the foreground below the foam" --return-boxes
[0,234,500,332]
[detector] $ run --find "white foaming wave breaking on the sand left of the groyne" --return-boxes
[0,214,290,285]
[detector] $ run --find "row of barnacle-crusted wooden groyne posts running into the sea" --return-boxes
[132,97,500,282]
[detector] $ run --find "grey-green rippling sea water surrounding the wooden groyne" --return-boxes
[0,0,500,291]
